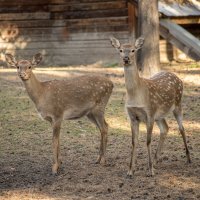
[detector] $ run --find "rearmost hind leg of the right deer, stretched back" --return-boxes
[173,106,191,163]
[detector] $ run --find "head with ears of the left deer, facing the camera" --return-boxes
[5,53,42,81]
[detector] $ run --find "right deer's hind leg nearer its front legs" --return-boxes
[154,119,169,163]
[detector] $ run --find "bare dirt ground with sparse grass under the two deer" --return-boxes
[0,64,200,200]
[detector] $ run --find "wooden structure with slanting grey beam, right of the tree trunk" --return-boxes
[158,0,200,62]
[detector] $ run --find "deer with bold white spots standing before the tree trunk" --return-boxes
[110,37,191,178]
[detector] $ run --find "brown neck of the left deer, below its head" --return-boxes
[23,72,43,104]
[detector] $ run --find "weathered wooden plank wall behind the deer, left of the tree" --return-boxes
[0,0,129,66]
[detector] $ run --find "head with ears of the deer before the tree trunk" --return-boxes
[110,37,144,66]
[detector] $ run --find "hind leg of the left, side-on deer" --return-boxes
[87,111,108,165]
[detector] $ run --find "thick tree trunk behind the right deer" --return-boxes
[138,0,160,77]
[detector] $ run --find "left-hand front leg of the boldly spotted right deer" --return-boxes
[127,120,139,177]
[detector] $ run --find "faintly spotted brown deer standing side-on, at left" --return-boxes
[5,53,113,175]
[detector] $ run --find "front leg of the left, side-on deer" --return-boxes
[52,121,61,174]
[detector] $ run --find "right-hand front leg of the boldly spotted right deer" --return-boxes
[147,121,154,176]
